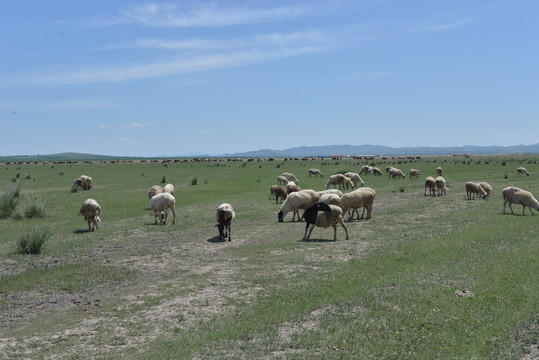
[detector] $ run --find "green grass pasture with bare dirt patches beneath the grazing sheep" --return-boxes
[0,155,539,359]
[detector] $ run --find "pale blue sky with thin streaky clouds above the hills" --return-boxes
[0,0,539,156]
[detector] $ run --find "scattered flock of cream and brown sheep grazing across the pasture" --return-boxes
[72,165,539,241]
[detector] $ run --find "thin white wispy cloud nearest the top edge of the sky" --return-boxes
[84,2,305,27]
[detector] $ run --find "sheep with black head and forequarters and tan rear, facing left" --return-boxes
[302,202,349,241]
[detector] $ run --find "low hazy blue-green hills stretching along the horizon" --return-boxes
[0,143,539,162]
